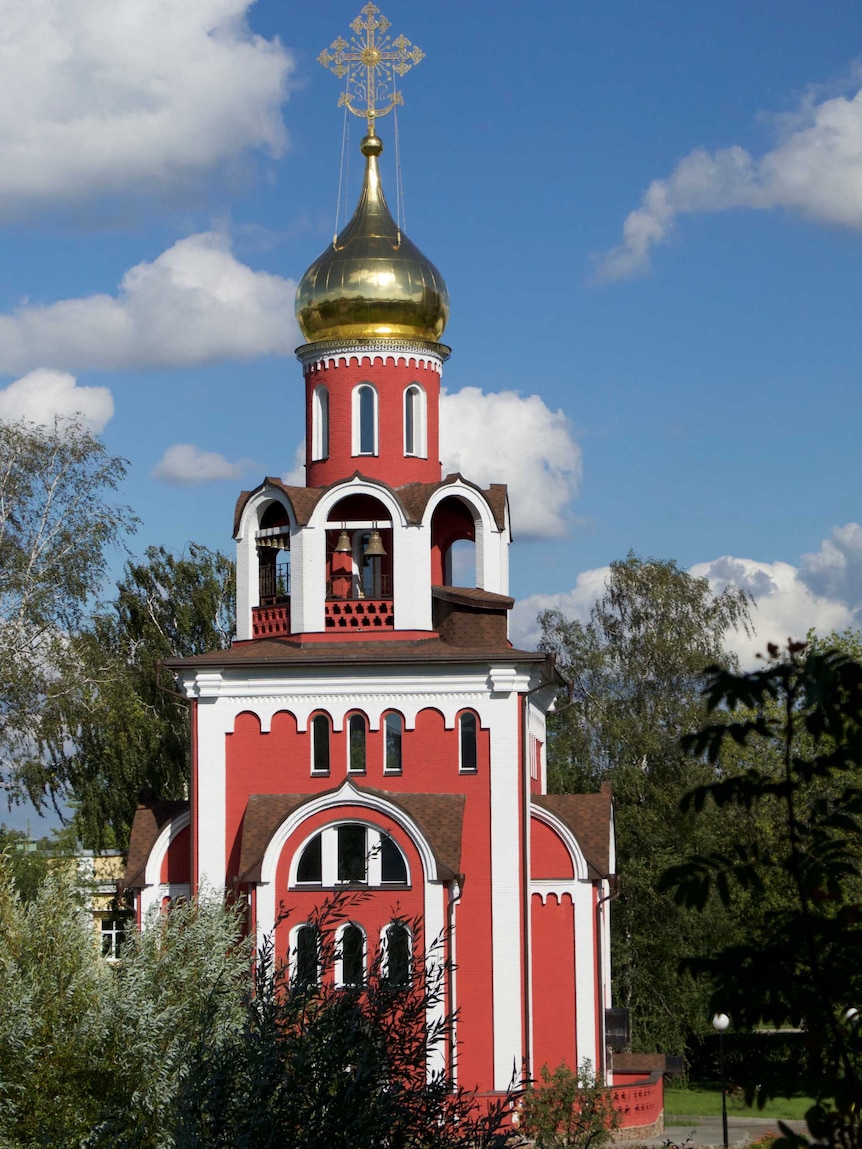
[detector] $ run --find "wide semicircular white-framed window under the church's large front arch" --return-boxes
[292,822,410,888]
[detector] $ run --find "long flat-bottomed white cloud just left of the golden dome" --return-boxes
[0,232,301,373]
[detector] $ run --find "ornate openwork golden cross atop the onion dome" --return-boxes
[317,3,425,136]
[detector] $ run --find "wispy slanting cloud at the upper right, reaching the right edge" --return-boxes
[598,81,862,279]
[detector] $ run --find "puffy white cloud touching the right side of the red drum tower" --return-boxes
[440,387,580,539]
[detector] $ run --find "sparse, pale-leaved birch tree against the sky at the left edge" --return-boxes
[0,421,137,804]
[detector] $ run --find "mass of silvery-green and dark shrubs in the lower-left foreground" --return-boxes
[0,873,509,1149]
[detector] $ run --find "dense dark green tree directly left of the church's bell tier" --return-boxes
[24,543,236,849]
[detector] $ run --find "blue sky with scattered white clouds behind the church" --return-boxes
[0,0,862,827]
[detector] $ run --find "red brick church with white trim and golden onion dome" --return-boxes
[121,5,660,1125]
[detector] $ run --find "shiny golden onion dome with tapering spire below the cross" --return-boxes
[297,134,449,344]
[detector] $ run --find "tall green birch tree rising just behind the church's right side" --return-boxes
[540,554,749,1052]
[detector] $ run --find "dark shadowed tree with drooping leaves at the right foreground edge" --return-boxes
[662,642,862,1149]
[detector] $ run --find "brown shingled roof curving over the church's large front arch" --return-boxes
[239,784,465,882]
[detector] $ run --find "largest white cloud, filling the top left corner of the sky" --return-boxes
[0,0,293,219]
